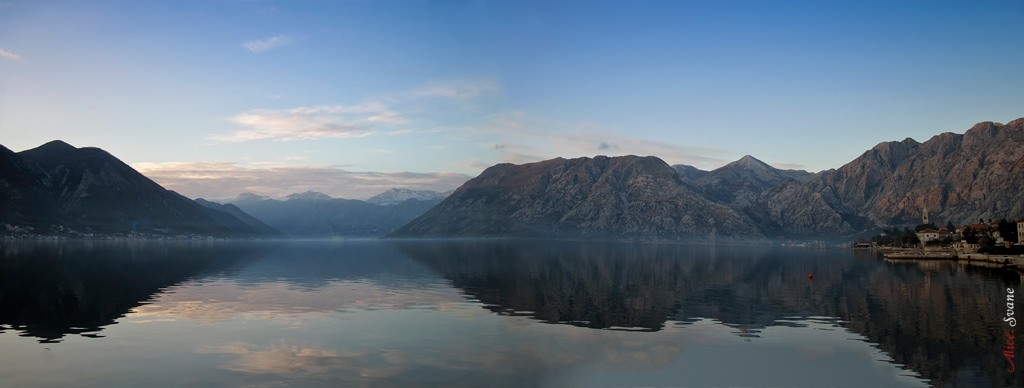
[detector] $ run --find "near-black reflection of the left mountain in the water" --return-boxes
[0,242,253,343]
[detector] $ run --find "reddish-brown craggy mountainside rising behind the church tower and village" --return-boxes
[782,119,1024,228]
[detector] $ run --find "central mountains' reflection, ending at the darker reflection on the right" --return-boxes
[400,242,835,333]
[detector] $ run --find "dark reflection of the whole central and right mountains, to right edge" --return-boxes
[399,241,1022,386]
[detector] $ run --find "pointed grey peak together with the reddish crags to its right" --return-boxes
[676,119,1024,236]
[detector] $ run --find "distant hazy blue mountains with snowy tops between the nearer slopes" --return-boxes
[231,191,440,236]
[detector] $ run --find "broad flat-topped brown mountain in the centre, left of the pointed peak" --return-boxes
[391,156,763,242]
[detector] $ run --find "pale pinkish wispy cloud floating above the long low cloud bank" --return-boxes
[211,102,407,142]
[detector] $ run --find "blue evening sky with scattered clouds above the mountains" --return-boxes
[0,0,1024,199]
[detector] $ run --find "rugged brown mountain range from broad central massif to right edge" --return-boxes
[391,119,1024,242]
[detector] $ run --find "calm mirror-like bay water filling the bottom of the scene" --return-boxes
[0,241,1024,387]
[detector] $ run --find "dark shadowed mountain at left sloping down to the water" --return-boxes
[0,141,270,236]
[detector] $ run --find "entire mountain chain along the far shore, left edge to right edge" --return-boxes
[0,119,1024,243]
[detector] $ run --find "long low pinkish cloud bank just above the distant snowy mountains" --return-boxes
[132,162,470,200]
